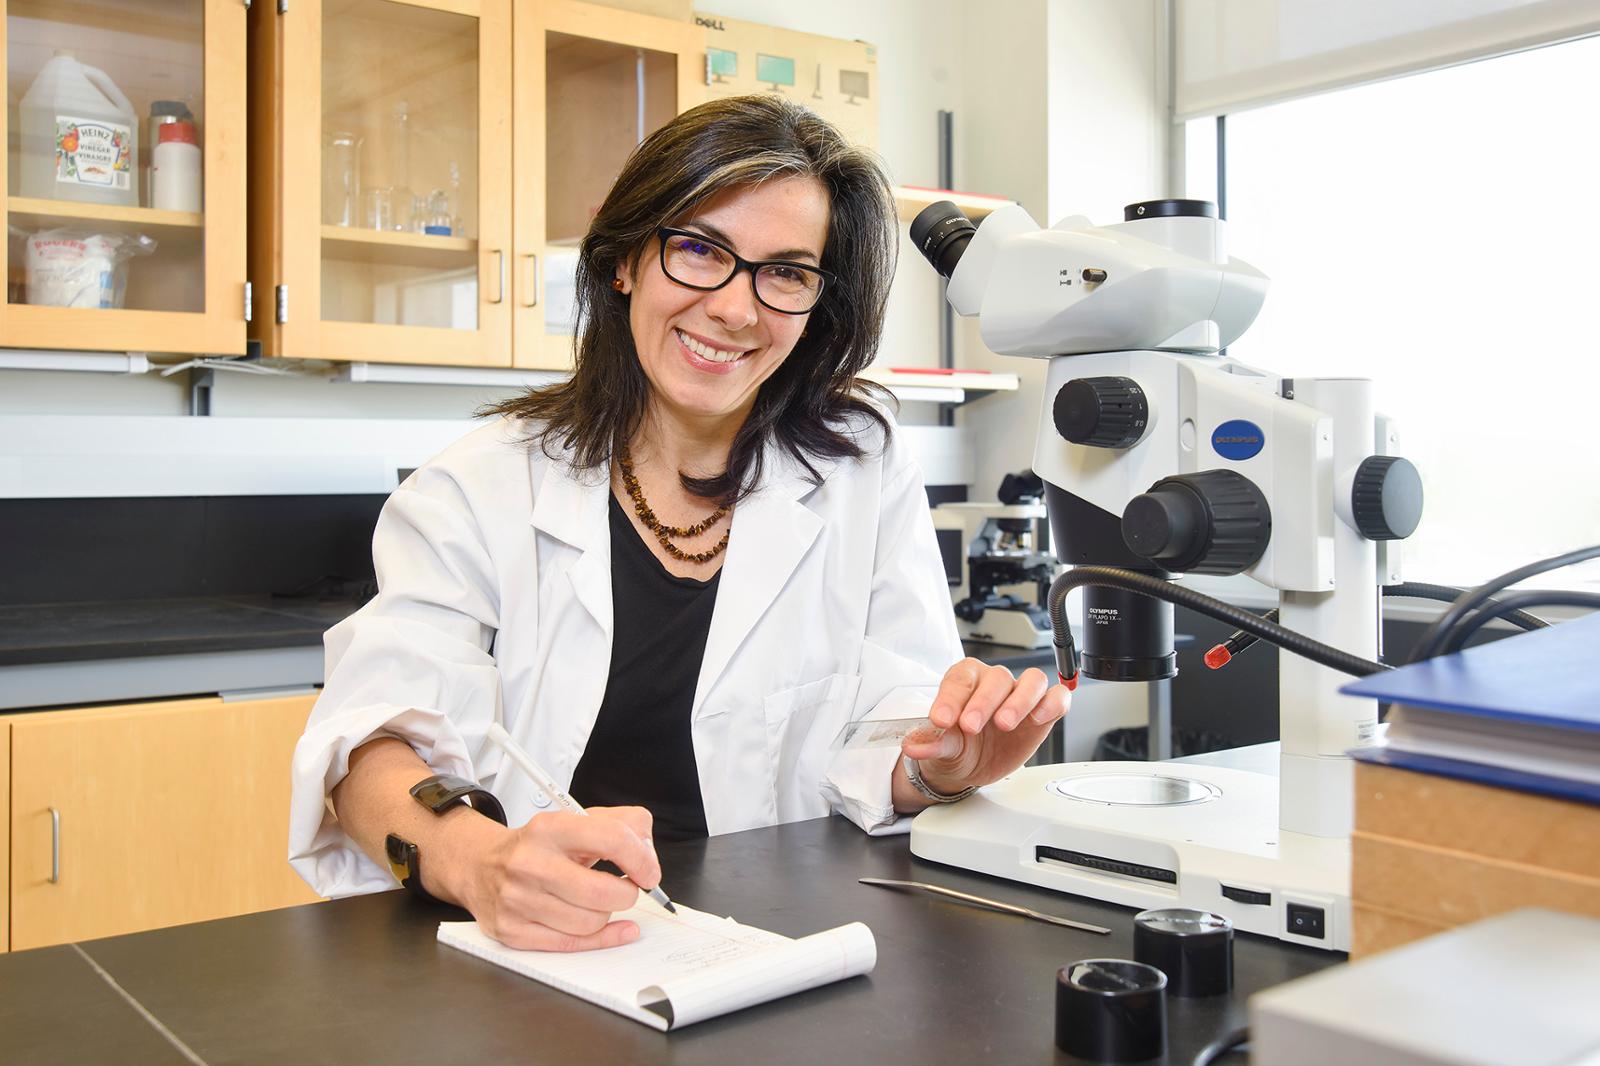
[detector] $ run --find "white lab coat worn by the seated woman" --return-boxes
[290,409,962,896]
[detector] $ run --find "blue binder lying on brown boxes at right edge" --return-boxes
[1339,613,1600,804]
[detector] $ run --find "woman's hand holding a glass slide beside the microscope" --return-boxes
[901,658,1072,792]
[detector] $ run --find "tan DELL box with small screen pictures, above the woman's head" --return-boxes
[694,11,878,149]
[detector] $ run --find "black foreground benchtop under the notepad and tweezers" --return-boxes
[0,818,1342,1066]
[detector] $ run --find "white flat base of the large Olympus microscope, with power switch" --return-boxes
[910,762,1350,951]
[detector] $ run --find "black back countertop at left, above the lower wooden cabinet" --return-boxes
[0,595,360,666]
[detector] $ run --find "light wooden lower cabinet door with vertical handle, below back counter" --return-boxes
[11,696,317,949]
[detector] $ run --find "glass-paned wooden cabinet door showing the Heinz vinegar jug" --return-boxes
[0,0,246,355]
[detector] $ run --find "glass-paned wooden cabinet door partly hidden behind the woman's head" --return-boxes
[512,0,706,370]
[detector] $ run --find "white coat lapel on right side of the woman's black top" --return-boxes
[693,448,834,719]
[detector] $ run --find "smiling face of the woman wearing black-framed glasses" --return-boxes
[618,176,829,435]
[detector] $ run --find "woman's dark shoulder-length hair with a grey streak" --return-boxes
[482,94,899,503]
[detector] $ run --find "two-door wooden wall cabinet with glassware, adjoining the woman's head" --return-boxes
[250,0,704,368]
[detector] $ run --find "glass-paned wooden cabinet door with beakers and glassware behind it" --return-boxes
[253,0,512,367]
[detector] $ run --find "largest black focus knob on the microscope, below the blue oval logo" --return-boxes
[1122,471,1272,575]
